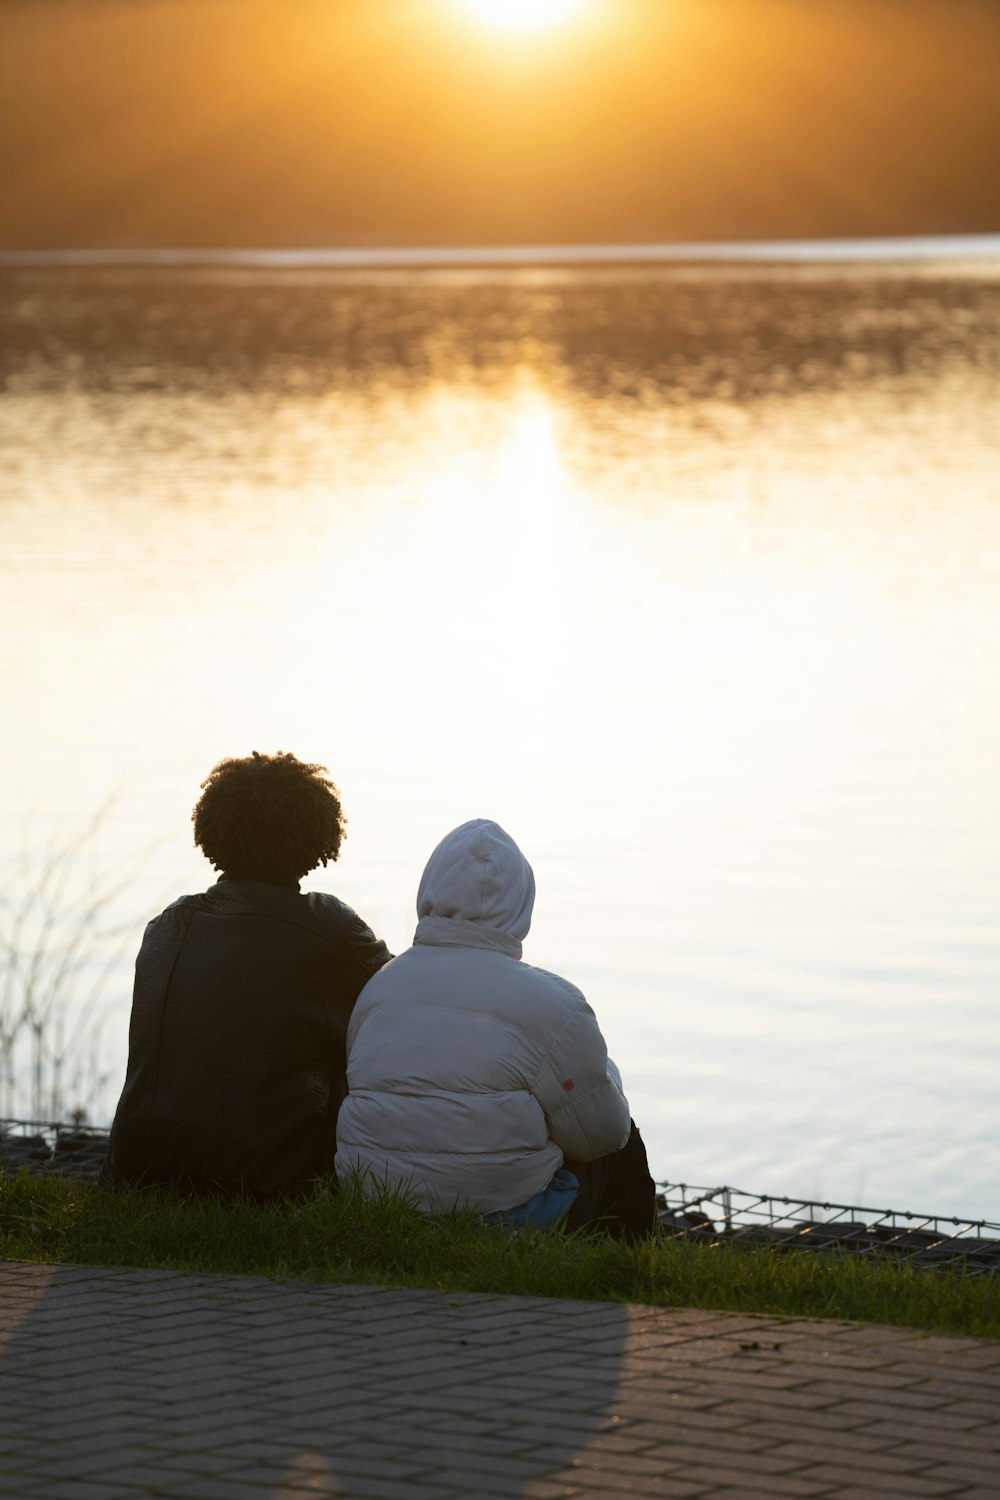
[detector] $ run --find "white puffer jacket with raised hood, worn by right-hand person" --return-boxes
[336,819,630,1214]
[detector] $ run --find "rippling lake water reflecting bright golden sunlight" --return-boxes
[0,261,1000,1218]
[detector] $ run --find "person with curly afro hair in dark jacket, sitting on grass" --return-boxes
[105,750,390,1199]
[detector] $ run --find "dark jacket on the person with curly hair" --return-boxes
[106,879,390,1197]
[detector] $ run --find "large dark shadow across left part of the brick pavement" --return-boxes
[0,1266,628,1500]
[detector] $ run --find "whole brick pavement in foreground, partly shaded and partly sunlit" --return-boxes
[0,1263,1000,1500]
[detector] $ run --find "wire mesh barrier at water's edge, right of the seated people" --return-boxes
[657,1182,1000,1275]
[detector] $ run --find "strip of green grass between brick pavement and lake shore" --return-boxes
[0,1175,1000,1338]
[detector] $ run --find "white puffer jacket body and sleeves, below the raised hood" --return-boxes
[337,942,602,1212]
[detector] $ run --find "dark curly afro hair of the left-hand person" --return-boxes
[190,750,345,885]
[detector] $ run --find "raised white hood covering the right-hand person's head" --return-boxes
[414,818,535,959]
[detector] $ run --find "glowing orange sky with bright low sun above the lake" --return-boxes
[0,0,1000,249]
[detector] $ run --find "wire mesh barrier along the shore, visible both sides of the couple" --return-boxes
[0,1121,1000,1275]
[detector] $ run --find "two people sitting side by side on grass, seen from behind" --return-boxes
[106,753,655,1239]
